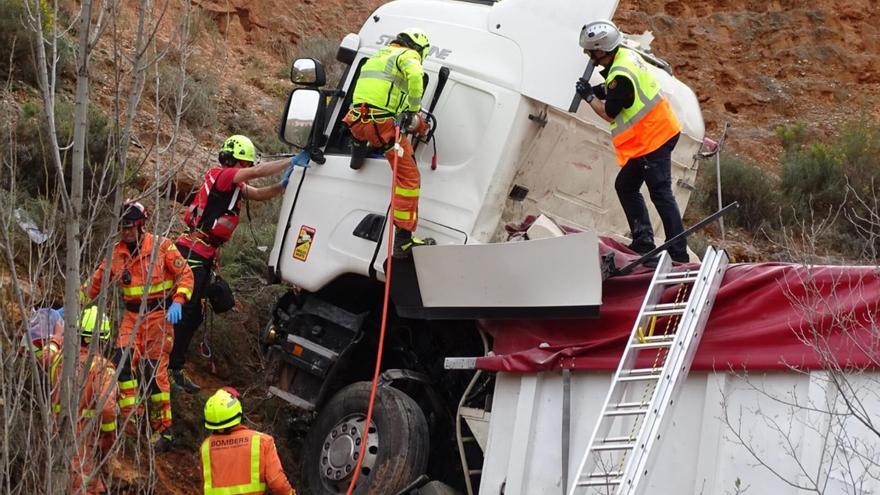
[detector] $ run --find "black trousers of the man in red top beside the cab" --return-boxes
[168,244,214,370]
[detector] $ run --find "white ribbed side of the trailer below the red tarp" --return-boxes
[480,371,880,495]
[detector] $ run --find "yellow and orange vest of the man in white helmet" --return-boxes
[605,47,681,167]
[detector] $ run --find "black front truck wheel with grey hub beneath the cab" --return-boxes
[302,382,430,495]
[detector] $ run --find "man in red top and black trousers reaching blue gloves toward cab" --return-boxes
[168,135,308,393]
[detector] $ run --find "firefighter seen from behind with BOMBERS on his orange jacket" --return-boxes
[199,387,296,495]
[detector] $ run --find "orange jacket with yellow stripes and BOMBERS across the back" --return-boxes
[199,425,296,495]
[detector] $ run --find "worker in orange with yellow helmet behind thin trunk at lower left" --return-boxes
[31,306,117,495]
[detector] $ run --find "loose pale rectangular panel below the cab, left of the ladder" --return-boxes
[413,232,602,308]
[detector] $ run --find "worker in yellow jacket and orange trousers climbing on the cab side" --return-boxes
[343,28,434,258]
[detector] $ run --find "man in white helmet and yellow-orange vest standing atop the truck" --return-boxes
[575,20,689,263]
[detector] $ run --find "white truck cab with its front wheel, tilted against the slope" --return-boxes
[263,0,704,495]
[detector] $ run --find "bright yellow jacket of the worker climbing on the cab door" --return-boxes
[351,45,424,115]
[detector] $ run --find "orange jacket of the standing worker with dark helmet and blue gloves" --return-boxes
[85,234,193,305]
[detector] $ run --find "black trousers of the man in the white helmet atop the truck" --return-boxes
[614,134,687,259]
